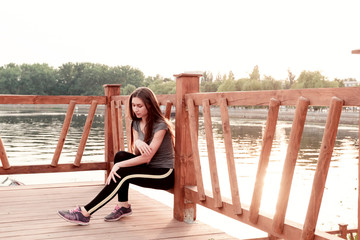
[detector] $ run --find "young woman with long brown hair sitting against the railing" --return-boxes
[58,87,175,225]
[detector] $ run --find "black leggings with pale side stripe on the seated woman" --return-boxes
[84,151,174,214]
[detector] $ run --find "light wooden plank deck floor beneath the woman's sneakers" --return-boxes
[0,183,239,240]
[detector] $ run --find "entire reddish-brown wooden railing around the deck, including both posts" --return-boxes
[0,74,360,239]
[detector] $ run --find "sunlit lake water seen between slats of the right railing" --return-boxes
[199,117,359,230]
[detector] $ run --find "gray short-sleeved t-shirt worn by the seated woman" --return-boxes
[133,121,175,168]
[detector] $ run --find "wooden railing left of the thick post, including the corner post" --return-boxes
[0,84,175,178]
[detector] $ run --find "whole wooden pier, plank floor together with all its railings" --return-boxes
[0,74,360,240]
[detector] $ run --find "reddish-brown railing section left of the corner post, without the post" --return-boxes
[0,92,108,175]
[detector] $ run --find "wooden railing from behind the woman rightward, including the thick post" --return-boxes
[106,74,360,239]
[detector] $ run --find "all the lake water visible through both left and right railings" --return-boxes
[0,105,359,233]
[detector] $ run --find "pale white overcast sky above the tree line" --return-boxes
[0,0,360,81]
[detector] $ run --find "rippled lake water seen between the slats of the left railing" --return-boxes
[0,108,104,165]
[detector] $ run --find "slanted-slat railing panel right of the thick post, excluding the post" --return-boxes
[184,81,360,240]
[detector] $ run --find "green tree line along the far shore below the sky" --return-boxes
[0,63,356,96]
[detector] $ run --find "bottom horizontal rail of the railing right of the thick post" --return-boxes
[185,186,342,240]
